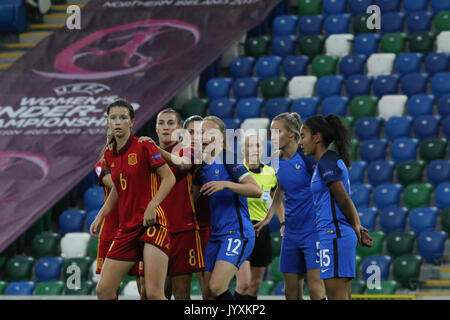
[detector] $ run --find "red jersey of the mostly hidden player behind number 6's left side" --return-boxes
[95,160,119,242]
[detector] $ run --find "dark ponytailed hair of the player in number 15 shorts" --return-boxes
[304,114,350,167]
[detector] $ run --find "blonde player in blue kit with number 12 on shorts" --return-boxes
[192,116,262,300]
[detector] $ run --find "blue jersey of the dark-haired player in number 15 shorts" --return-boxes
[311,150,354,239]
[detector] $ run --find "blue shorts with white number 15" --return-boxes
[320,233,358,280]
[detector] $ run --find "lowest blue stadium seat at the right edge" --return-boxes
[417,231,447,264]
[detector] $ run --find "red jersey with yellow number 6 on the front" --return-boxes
[105,135,167,233]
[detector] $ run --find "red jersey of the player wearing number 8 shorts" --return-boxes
[158,143,198,232]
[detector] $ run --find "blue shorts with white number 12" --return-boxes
[205,234,255,272]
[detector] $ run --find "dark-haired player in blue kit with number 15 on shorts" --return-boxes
[300,114,372,300]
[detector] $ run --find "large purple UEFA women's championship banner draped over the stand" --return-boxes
[0,0,280,252]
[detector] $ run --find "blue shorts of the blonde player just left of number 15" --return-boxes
[280,233,320,274]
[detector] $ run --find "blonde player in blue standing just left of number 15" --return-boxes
[255,112,325,300]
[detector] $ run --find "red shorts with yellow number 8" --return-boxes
[168,230,205,276]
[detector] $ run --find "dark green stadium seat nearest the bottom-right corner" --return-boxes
[392,254,424,290]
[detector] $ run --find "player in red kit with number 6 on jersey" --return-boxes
[90,99,175,300]
